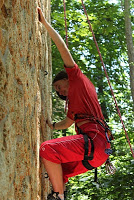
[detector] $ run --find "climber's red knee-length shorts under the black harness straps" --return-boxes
[40,123,110,182]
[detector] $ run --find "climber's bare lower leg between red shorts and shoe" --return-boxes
[42,158,65,194]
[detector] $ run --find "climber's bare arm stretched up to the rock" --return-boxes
[38,7,75,68]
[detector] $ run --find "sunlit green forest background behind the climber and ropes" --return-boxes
[51,0,134,200]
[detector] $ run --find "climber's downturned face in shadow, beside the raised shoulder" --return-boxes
[53,78,69,96]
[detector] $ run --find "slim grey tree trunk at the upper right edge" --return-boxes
[124,0,134,109]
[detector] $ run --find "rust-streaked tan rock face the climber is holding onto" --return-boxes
[0,0,52,200]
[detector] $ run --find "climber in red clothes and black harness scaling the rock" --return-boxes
[38,7,110,200]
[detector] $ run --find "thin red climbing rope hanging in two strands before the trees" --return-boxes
[63,0,134,158]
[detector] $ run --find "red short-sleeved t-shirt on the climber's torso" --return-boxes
[65,64,104,122]
